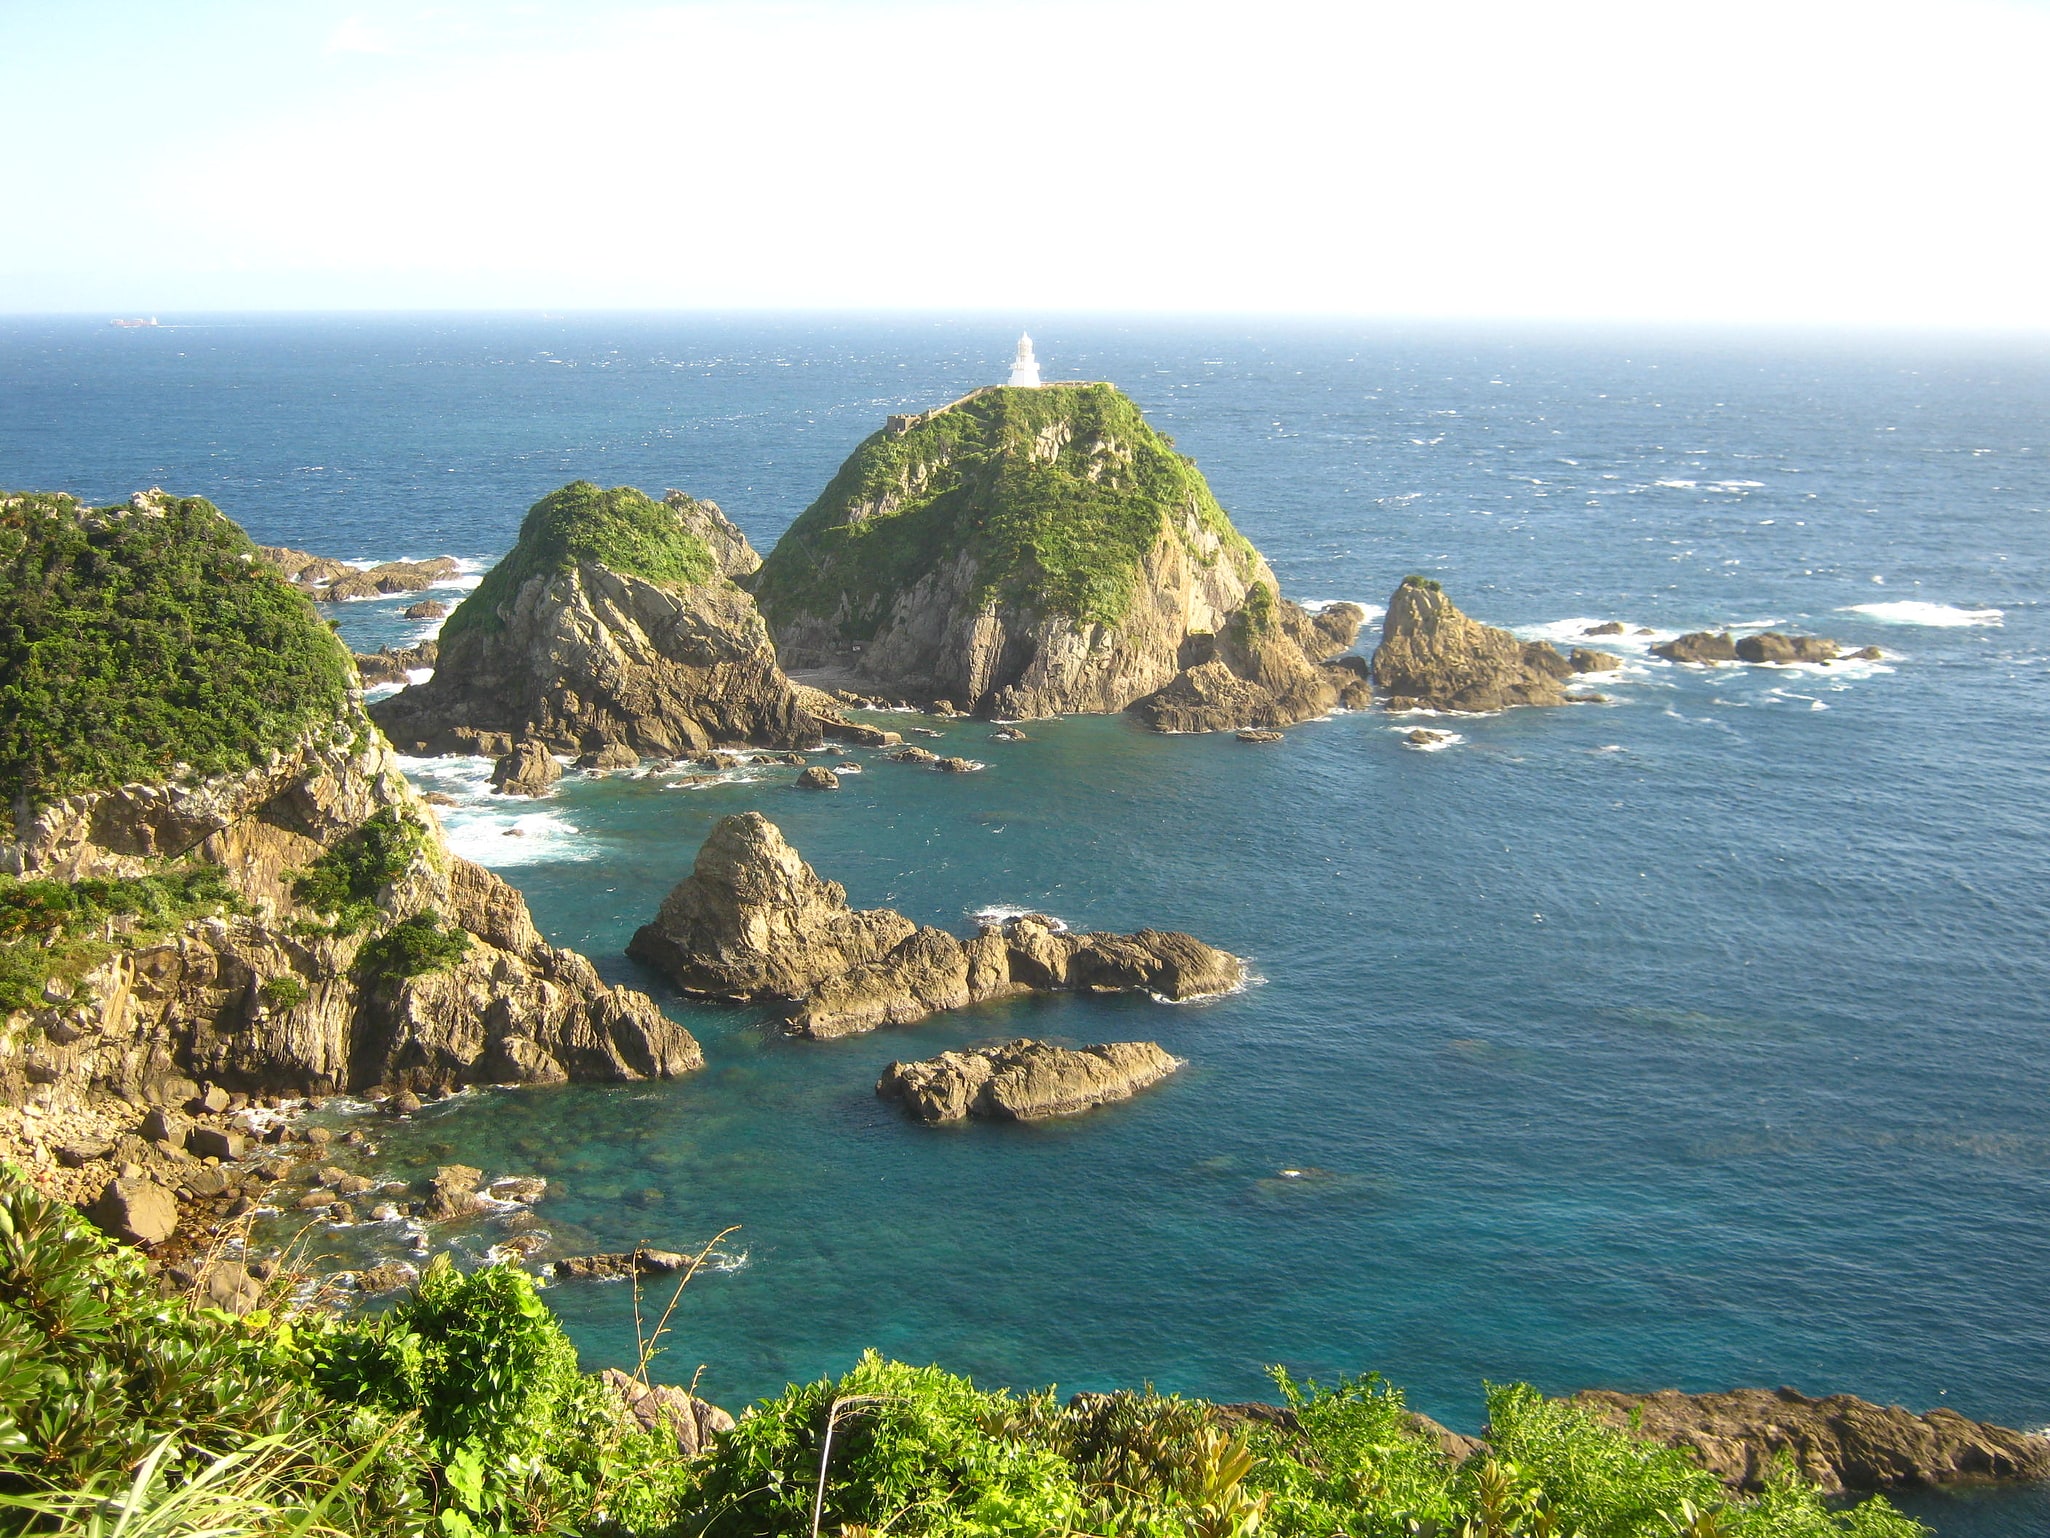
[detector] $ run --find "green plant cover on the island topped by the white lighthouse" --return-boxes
[750,383,1257,640]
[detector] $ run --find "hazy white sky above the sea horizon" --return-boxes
[0,0,2050,330]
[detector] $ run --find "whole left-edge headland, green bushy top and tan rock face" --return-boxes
[0,498,701,1205]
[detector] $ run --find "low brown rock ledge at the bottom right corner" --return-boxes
[1568,1388,2050,1495]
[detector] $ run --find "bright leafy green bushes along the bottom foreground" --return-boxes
[0,1171,1925,1538]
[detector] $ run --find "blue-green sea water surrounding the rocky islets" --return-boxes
[0,316,2050,1538]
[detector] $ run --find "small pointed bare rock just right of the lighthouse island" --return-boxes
[1374,576,1572,712]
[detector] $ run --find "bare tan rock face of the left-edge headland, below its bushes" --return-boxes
[0,714,701,1114]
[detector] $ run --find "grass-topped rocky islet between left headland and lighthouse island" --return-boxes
[371,482,822,757]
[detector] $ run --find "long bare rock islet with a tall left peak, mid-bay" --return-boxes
[627,812,1244,1038]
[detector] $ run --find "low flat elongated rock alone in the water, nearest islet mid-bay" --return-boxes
[875,1038,1181,1122]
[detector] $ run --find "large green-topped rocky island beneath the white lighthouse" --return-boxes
[752,383,1363,730]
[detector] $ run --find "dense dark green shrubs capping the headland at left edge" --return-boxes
[0,492,353,806]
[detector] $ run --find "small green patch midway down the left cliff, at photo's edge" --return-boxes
[0,865,242,1013]
